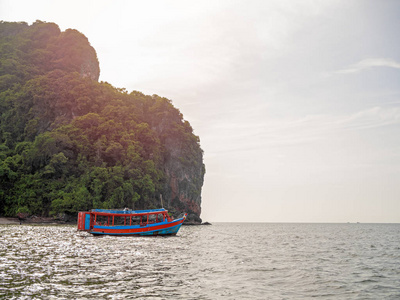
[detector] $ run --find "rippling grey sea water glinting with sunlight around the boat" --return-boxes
[0,223,400,300]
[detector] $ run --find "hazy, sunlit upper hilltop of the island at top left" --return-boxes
[0,21,100,82]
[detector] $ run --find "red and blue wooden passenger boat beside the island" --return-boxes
[78,208,187,236]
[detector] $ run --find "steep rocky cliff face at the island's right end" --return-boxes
[147,95,205,223]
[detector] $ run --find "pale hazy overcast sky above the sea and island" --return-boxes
[0,0,400,223]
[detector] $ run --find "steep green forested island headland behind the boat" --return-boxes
[0,21,205,223]
